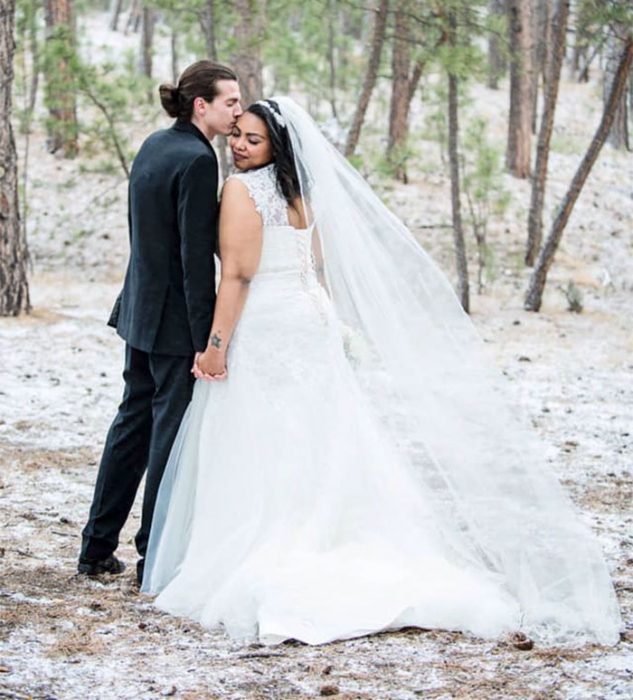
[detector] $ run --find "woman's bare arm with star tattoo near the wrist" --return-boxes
[194,178,262,379]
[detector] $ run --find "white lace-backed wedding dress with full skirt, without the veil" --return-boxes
[143,166,613,644]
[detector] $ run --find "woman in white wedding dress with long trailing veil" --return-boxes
[142,97,620,644]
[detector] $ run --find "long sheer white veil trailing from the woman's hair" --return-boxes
[273,97,620,644]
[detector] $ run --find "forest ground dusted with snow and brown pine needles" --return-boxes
[0,17,633,700]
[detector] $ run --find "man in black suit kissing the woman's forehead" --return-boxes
[77,61,242,583]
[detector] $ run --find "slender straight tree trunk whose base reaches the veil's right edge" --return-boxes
[448,14,470,313]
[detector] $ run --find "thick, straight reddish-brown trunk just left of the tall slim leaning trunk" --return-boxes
[506,0,533,178]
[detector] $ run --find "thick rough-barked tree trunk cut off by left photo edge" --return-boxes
[0,0,31,316]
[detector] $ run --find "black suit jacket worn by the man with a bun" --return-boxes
[109,121,218,355]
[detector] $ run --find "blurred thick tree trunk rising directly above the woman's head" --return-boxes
[233,0,266,105]
